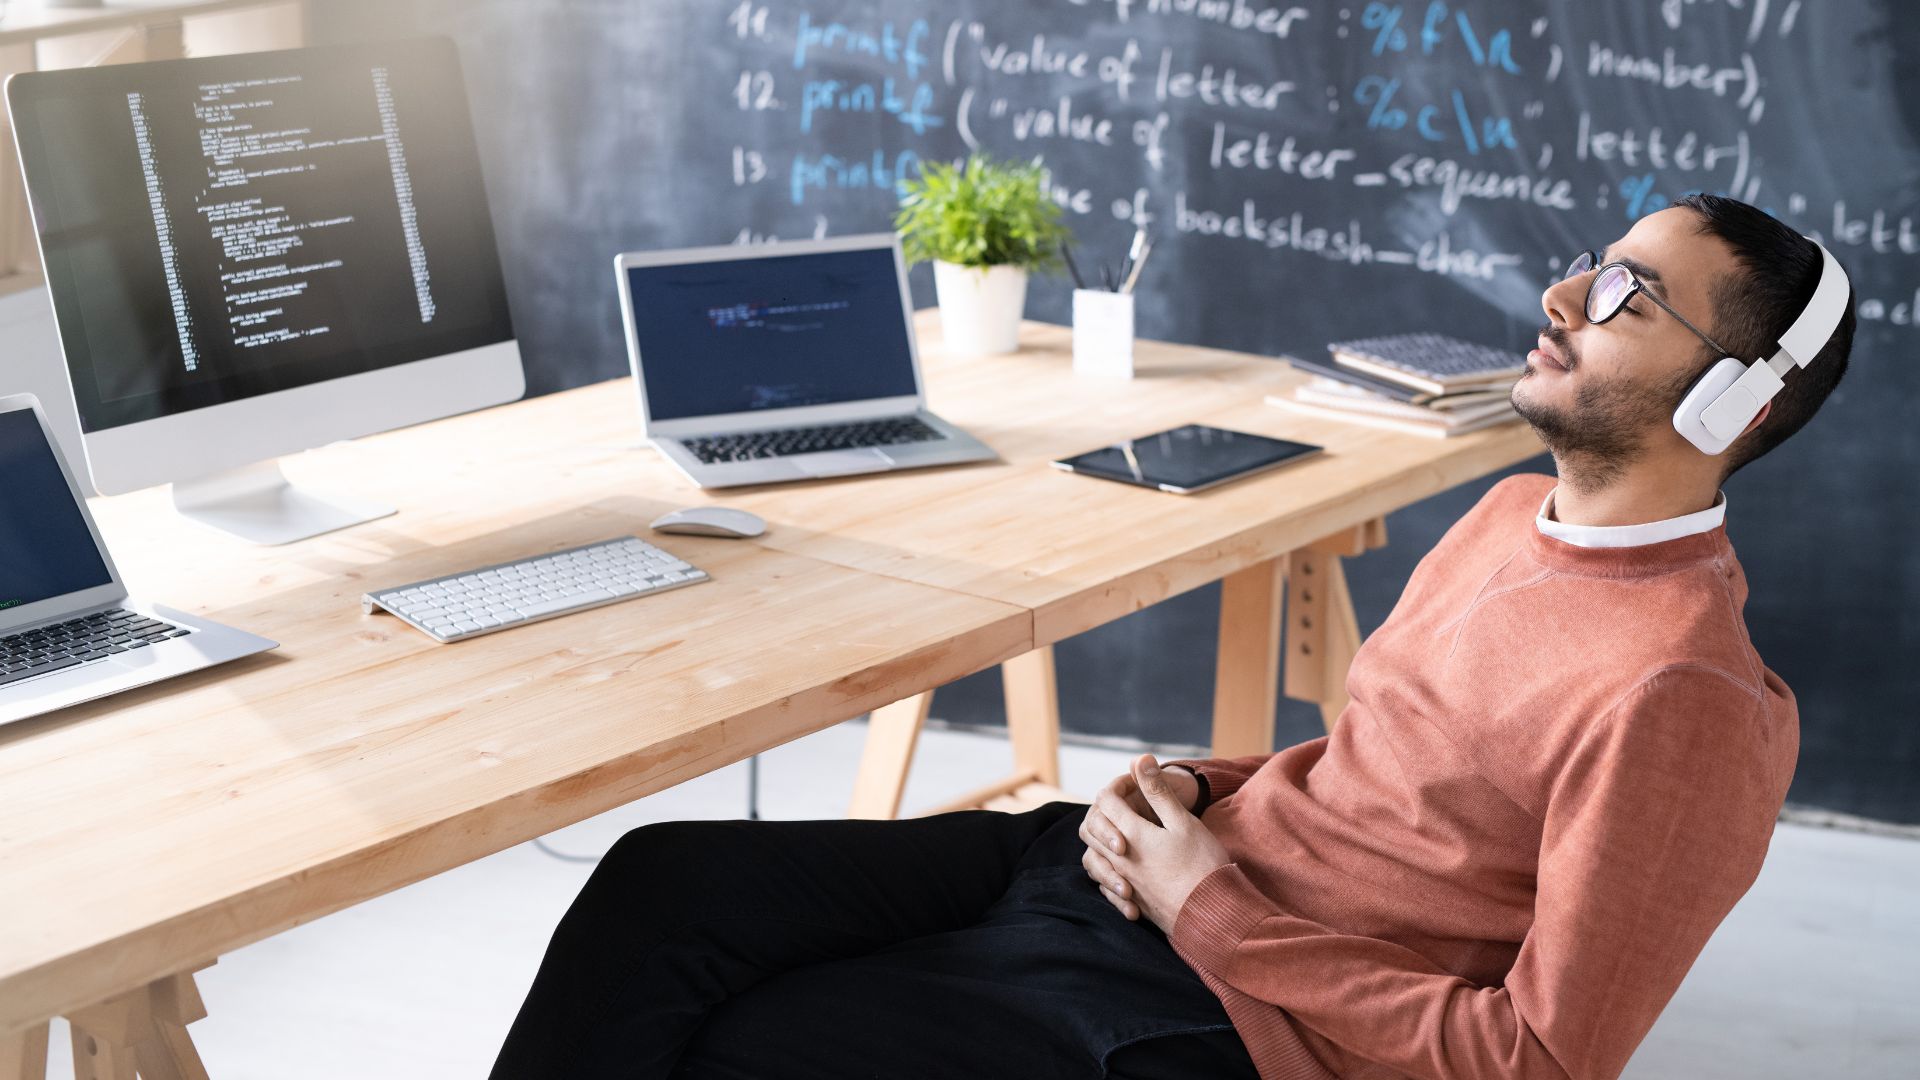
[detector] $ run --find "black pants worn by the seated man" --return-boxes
[493,803,1256,1080]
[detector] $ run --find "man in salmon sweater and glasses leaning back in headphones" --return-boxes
[493,196,1853,1080]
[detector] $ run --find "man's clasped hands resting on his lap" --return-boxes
[1079,753,1233,934]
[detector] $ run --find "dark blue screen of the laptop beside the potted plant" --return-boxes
[626,248,918,421]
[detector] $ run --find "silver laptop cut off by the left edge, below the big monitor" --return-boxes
[0,394,275,724]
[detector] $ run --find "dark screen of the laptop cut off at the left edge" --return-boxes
[0,409,113,609]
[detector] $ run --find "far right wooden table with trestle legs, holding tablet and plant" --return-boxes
[655,311,1544,817]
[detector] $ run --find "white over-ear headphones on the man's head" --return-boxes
[1674,236,1851,454]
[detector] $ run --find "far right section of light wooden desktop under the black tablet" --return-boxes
[691,311,1542,644]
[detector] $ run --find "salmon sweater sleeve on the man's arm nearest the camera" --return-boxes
[1171,667,1786,1080]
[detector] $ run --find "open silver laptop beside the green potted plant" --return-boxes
[614,233,995,488]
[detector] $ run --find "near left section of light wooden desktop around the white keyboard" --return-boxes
[0,490,1031,1036]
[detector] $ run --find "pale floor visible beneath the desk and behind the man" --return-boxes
[37,723,1920,1080]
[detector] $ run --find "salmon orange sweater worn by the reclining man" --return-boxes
[1171,475,1799,1080]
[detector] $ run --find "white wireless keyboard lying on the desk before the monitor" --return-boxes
[361,536,708,642]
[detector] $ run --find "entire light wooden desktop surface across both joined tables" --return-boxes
[0,313,1540,1038]
